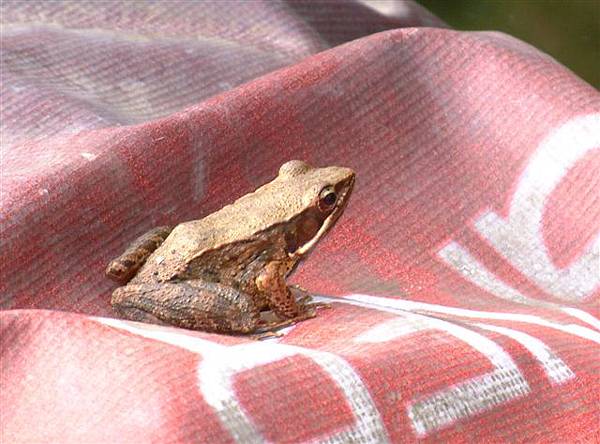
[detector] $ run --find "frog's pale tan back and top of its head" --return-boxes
[132,161,354,283]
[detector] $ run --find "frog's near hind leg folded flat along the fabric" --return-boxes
[111,280,262,333]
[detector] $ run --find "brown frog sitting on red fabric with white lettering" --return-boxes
[105,160,356,335]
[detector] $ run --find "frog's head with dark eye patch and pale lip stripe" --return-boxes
[275,160,355,259]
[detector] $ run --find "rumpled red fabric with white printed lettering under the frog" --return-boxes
[0,0,600,443]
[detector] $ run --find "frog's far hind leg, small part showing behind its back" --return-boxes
[106,227,174,285]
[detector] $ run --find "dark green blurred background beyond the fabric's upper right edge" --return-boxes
[417,0,600,88]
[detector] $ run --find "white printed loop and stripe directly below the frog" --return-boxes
[95,318,389,443]
